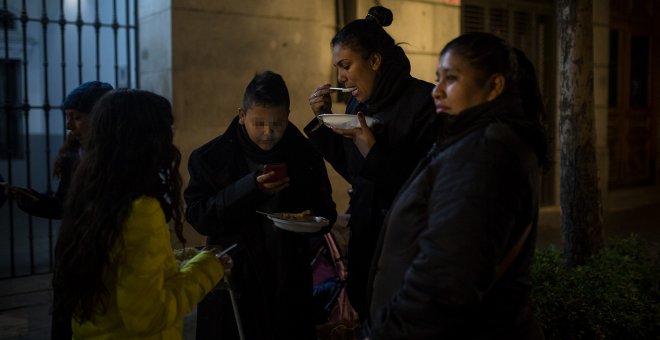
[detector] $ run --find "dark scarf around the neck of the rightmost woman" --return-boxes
[436,93,548,164]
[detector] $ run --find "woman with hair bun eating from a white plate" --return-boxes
[304,6,437,319]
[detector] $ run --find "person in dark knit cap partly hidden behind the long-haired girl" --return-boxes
[6,81,112,219]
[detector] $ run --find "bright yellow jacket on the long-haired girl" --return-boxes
[71,196,223,339]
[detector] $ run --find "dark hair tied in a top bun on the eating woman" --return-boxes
[330,6,398,62]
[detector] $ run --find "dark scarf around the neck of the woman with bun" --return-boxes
[356,45,412,116]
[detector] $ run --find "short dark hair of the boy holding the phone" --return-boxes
[238,71,289,112]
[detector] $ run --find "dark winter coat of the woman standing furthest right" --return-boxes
[370,96,541,339]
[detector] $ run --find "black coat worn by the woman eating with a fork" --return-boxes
[305,76,438,318]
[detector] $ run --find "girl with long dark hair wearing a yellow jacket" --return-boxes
[53,89,231,339]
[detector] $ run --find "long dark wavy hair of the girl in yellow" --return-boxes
[53,89,185,321]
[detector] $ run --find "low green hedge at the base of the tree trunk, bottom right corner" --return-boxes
[531,235,660,340]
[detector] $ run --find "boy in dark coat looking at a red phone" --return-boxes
[184,71,337,340]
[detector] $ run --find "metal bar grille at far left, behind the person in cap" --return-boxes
[0,0,140,278]
